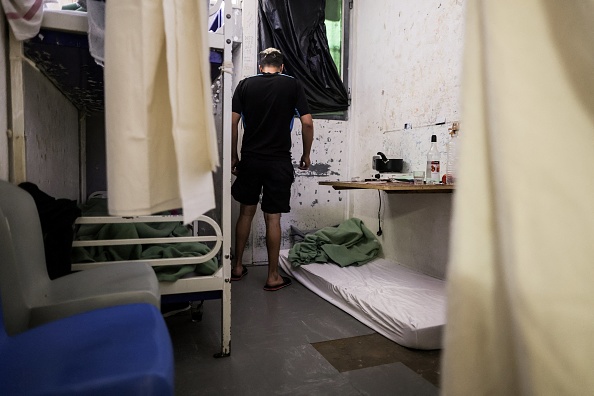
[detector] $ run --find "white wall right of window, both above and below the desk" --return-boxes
[349,0,464,278]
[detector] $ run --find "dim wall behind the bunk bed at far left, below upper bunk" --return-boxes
[0,10,80,199]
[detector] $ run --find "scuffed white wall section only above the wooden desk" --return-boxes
[351,0,464,177]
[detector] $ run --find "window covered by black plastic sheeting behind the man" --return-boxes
[258,0,351,119]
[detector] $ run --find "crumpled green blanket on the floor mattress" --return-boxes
[289,218,381,267]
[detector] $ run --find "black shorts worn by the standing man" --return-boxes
[231,158,295,213]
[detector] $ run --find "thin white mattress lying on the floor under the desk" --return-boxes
[279,250,446,349]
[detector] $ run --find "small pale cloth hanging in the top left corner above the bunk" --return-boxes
[2,0,43,40]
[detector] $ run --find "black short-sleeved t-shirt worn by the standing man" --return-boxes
[232,73,309,159]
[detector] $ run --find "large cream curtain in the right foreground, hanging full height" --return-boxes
[442,0,594,396]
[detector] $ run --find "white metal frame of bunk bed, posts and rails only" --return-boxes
[9,0,234,357]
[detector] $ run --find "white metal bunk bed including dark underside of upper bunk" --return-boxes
[9,0,235,357]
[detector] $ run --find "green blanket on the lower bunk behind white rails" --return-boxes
[72,199,219,282]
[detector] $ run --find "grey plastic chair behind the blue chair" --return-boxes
[0,181,160,335]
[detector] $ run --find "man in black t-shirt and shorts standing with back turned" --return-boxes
[231,48,314,291]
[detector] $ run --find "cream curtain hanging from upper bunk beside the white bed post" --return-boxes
[105,0,219,223]
